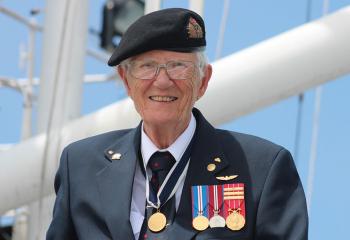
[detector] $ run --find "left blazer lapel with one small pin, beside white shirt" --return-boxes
[96,125,140,239]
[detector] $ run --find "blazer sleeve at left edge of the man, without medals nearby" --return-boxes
[46,148,78,240]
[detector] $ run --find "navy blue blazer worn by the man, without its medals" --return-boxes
[46,109,308,240]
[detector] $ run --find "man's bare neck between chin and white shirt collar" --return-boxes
[143,115,191,149]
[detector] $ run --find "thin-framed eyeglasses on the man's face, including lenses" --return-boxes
[129,61,196,80]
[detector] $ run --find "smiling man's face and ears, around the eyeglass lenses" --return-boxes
[118,50,211,128]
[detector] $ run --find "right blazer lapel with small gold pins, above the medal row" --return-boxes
[169,109,229,240]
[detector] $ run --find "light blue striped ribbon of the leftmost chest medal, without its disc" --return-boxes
[192,186,208,218]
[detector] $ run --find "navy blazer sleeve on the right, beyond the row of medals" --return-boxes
[255,149,308,240]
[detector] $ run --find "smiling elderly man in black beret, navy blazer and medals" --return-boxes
[47,8,308,240]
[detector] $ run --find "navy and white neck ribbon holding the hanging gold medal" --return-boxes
[144,129,196,209]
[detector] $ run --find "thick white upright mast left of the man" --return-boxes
[29,0,88,240]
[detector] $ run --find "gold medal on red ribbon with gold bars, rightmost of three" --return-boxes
[224,183,246,231]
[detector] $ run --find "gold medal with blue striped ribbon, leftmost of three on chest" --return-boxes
[192,186,209,231]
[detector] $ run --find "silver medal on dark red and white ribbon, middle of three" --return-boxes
[208,185,226,228]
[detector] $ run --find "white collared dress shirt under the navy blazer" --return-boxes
[130,114,196,240]
